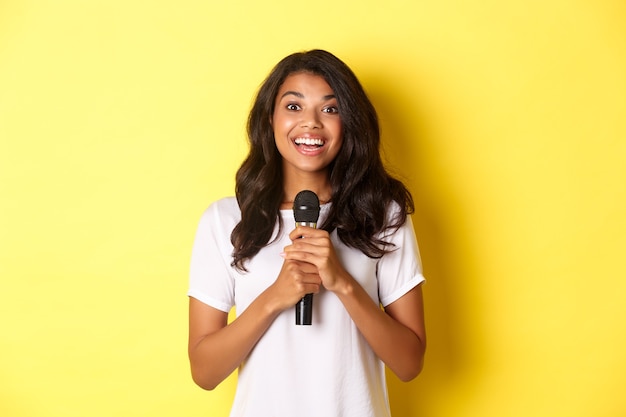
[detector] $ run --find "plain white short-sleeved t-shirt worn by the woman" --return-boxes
[188,197,424,417]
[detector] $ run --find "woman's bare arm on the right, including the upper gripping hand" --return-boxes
[285,227,426,381]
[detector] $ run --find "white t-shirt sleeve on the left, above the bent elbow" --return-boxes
[187,199,239,312]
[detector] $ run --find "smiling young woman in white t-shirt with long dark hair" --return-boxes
[188,50,426,417]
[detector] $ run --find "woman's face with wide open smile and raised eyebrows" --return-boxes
[272,72,343,176]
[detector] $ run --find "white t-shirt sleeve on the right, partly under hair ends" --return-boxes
[377,211,425,307]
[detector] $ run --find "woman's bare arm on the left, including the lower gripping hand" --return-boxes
[188,261,320,390]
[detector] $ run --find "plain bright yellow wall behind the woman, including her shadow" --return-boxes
[0,0,626,417]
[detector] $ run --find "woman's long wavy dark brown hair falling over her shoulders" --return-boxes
[231,49,414,271]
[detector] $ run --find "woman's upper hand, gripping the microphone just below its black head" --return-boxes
[283,226,350,292]
